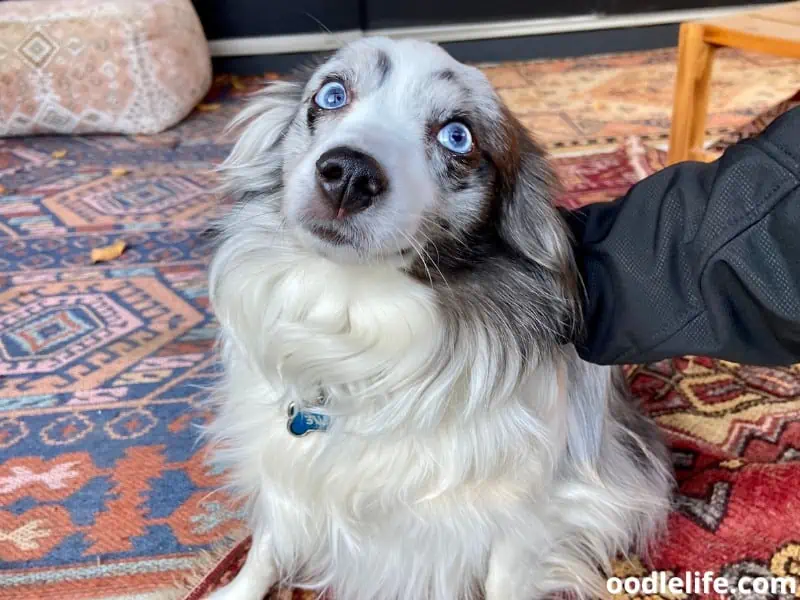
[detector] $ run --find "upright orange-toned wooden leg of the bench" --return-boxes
[667,23,716,164]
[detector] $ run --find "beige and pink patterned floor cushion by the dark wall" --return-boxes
[0,0,211,136]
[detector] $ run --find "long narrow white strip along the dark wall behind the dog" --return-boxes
[209,4,780,57]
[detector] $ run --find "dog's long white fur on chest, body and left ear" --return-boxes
[203,36,670,600]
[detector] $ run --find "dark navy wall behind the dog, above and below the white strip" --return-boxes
[200,0,788,75]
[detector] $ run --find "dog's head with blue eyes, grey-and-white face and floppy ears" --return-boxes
[224,38,575,352]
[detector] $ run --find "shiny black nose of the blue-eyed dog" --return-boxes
[317,146,388,218]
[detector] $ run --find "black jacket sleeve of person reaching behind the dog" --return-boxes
[567,108,800,365]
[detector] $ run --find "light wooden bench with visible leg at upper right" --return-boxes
[667,2,800,164]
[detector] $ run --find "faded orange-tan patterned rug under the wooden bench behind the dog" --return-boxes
[478,49,800,149]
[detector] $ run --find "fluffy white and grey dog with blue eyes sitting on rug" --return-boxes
[203,38,672,600]
